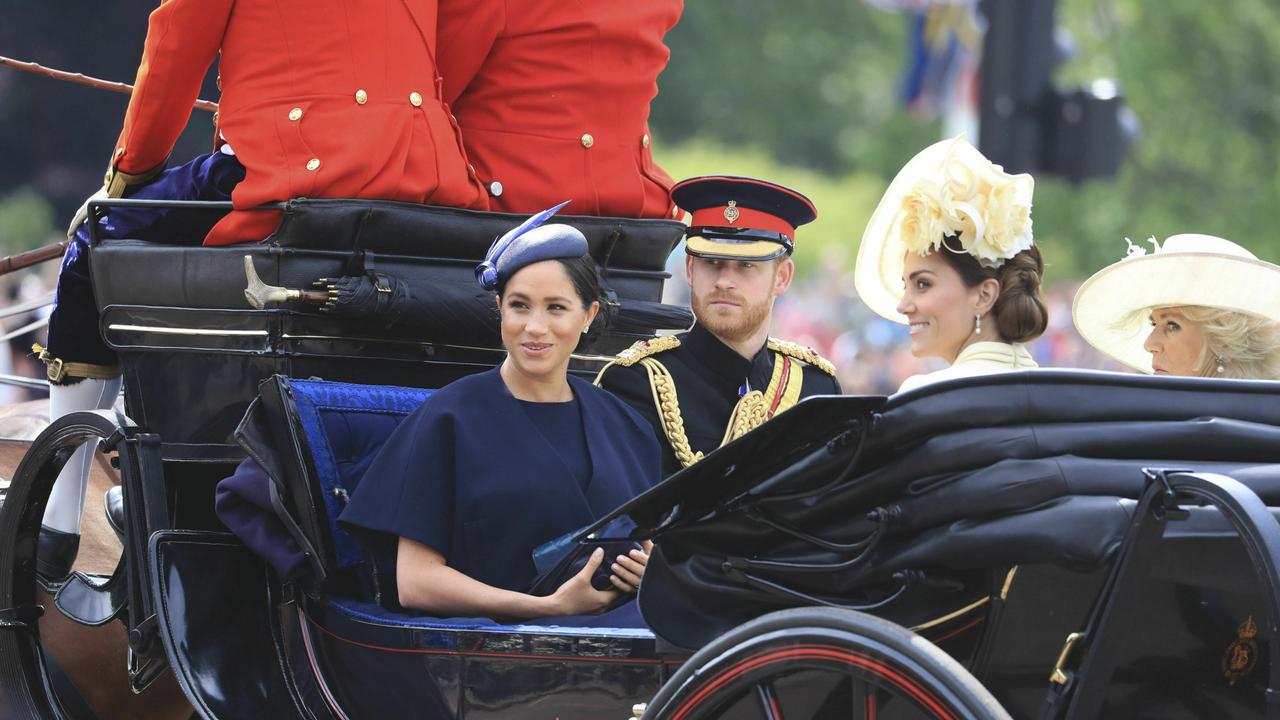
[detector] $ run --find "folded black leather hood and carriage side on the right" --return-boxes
[596,372,1280,717]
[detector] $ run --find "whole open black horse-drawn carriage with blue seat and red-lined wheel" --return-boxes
[0,201,1280,720]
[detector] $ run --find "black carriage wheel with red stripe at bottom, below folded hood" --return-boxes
[644,607,1009,720]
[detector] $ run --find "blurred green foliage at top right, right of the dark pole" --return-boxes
[1036,0,1280,274]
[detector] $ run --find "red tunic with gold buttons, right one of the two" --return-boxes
[439,0,684,218]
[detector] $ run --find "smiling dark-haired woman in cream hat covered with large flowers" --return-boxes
[854,138,1048,392]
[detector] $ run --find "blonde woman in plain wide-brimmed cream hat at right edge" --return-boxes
[1071,234,1280,380]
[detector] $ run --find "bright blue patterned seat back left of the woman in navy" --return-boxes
[289,380,434,568]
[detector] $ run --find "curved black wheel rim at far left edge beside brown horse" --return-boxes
[0,413,128,720]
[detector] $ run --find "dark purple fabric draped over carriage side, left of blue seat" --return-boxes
[214,457,306,579]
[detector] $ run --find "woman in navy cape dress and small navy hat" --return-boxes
[340,203,660,619]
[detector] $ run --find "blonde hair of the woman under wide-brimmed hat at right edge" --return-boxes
[1179,305,1280,380]
